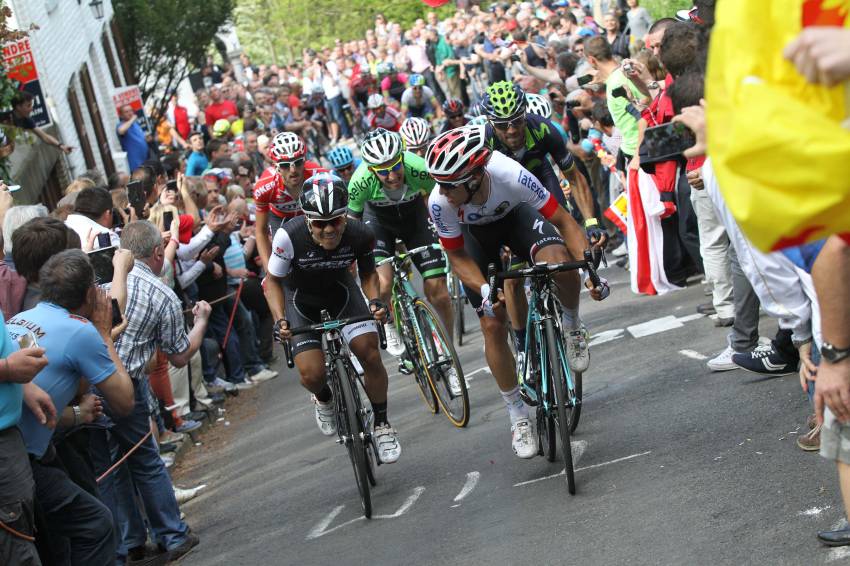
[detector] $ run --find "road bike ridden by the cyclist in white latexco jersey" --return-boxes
[488,250,601,495]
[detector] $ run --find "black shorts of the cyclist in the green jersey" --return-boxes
[363,206,448,279]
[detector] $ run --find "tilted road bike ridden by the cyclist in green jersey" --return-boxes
[378,244,469,428]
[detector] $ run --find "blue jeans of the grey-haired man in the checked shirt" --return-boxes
[91,380,189,557]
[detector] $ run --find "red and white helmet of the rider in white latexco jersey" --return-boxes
[425,125,492,184]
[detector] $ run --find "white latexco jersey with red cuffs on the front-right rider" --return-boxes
[428,152,558,251]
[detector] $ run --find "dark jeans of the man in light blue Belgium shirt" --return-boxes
[30,449,118,566]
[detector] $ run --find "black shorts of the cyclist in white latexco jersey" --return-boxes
[462,204,564,316]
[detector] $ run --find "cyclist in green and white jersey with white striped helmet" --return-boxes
[348,128,460,393]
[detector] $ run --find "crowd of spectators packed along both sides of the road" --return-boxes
[0,0,850,565]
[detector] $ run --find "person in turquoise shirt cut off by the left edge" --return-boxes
[0,320,48,564]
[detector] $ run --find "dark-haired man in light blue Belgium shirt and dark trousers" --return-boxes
[9,250,134,564]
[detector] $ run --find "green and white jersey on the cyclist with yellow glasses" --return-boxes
[348,151,434,219]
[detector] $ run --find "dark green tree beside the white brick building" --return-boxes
[112,0,234,113]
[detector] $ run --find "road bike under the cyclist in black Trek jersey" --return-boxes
[283,310,387,519]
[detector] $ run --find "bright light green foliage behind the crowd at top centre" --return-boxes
[235,0,454,64]
